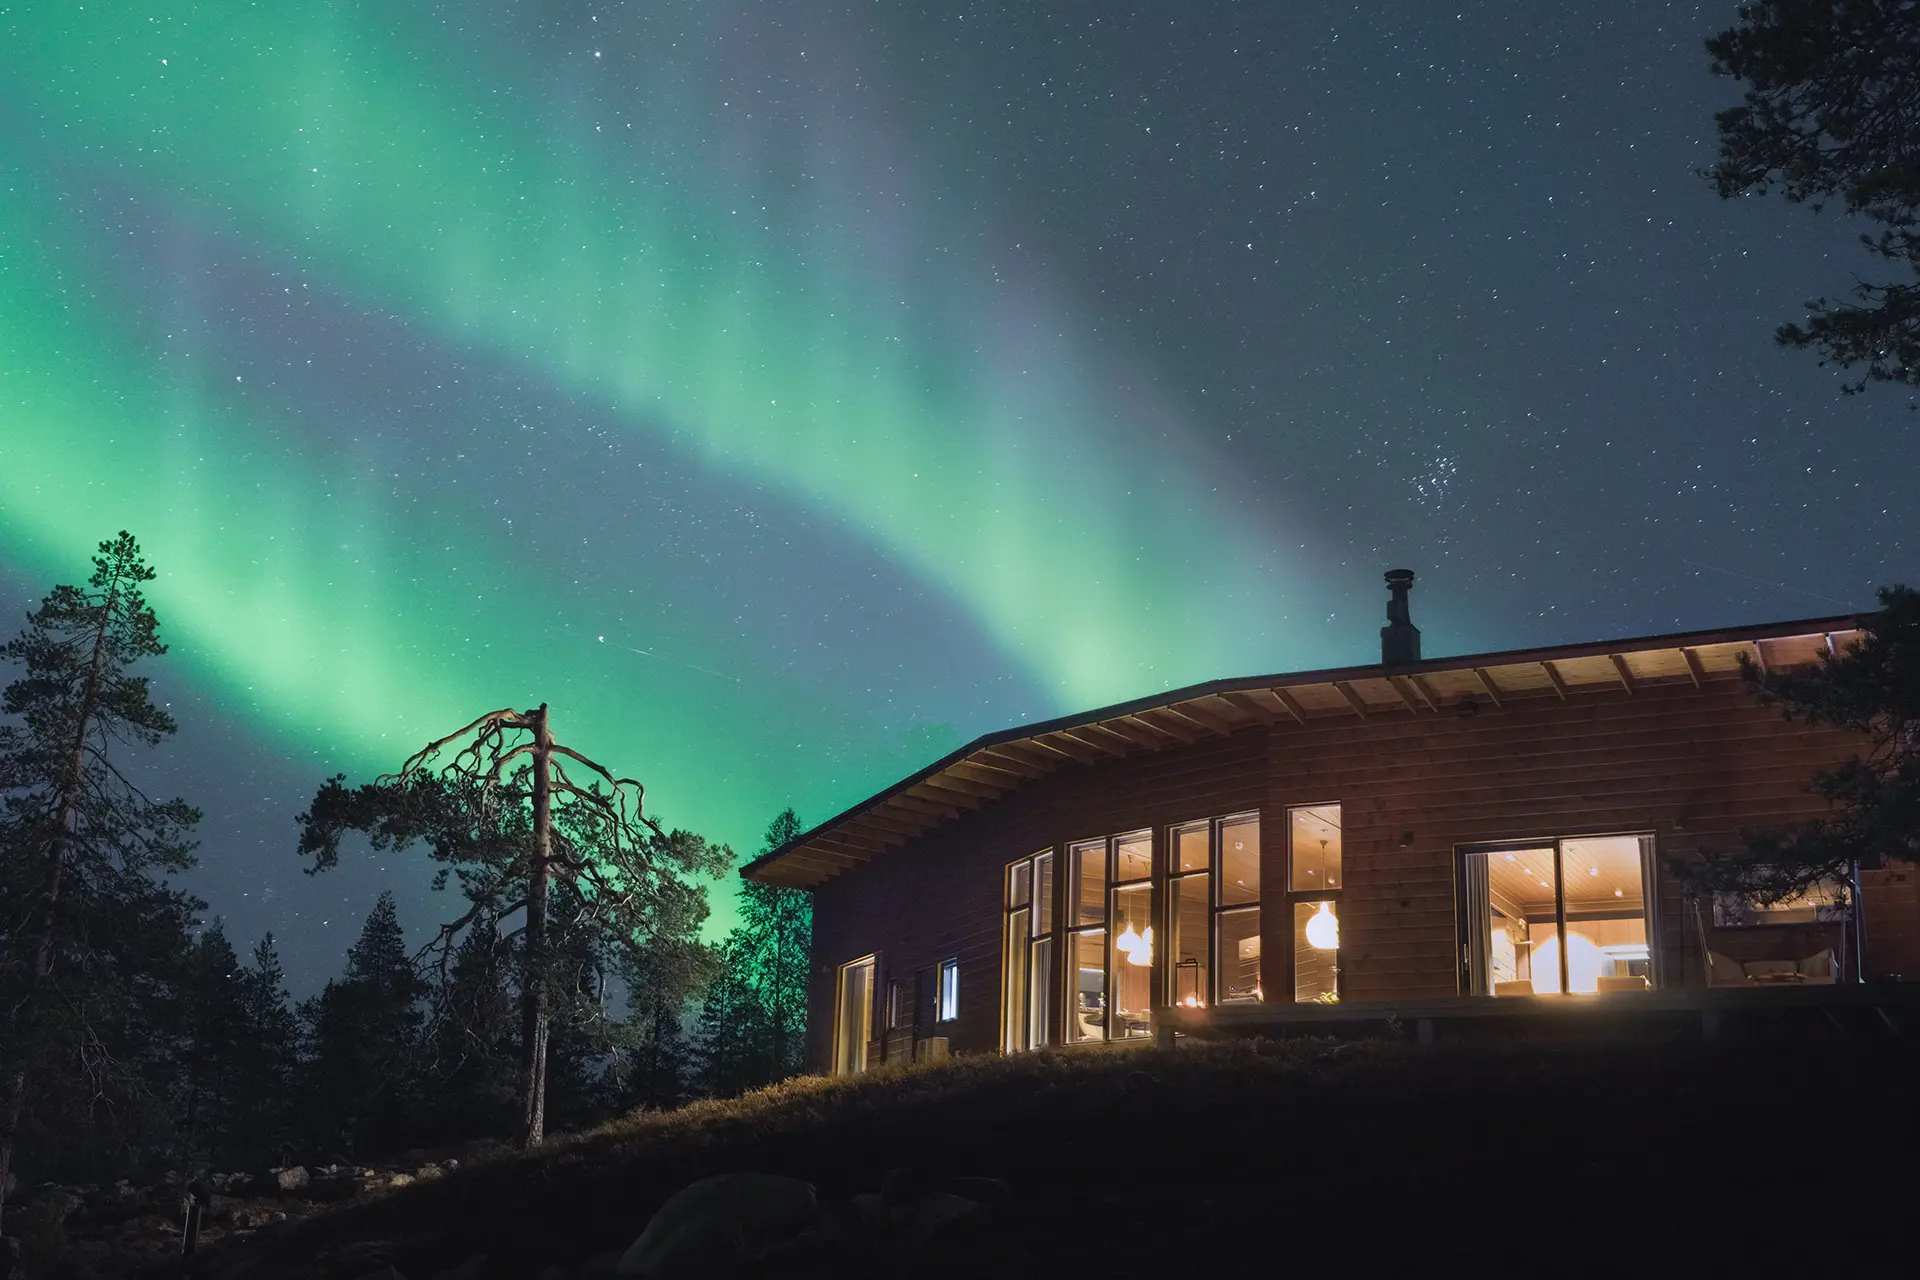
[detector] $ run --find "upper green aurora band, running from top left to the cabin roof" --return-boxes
[8,4,1336,704]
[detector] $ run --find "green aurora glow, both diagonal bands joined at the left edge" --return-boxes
[0,0,1329,871]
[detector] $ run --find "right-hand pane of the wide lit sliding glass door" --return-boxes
[1549,835,1653,994]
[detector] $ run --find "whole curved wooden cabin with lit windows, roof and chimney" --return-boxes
[745,570,1920,1073]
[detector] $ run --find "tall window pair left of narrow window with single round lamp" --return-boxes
[1165,814,1265,1007]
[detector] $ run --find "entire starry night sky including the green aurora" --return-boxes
[0,0,1920,992]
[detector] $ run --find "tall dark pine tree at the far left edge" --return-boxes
[0,532,200,1220]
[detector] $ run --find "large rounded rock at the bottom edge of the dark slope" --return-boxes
[614,1173,820,1280]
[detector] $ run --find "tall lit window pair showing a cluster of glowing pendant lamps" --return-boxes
[1068,831,1154,1042]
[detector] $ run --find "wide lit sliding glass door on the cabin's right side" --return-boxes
[1459,835,1655,996]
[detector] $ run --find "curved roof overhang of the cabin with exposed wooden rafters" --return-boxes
[741,614,1859,889]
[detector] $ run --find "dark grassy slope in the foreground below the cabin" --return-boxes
[105,1023,1920,1280]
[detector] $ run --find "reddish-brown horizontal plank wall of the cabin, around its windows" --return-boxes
[808,677,1889,1069]
